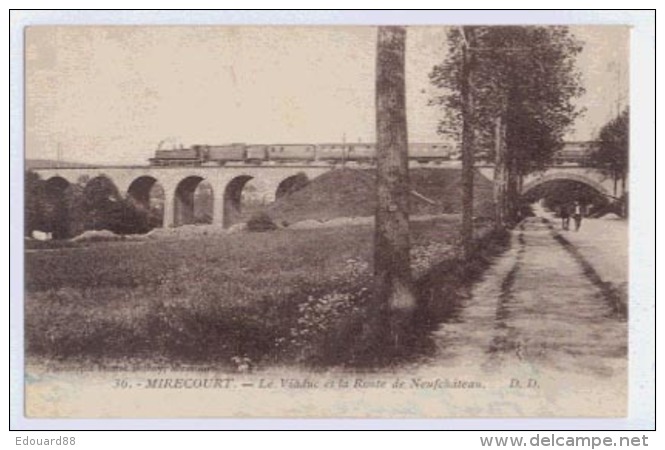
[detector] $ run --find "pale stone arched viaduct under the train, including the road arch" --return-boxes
[34,161,616,227]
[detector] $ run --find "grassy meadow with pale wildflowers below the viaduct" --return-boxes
[25,218,488,366]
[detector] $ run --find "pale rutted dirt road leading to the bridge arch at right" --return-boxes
[428,214,628,384]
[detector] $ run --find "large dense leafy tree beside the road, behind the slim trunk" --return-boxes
[430,26,583,225]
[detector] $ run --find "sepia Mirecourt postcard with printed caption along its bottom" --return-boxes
[12,9,653,426]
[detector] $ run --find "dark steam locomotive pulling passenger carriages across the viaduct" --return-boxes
[150,143,460,166]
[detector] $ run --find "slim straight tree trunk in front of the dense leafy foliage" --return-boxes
[461,27,475,259]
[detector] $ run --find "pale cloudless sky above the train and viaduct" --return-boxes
[25,26,629,164]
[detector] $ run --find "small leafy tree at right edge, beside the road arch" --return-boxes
[589,109,630,197]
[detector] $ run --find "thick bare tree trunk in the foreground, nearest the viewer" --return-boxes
[374,27,416,346]
